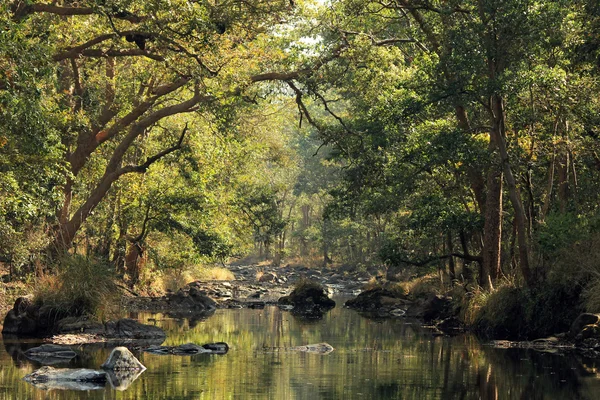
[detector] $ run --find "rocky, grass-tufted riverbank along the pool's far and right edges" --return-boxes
[2,264,600,355]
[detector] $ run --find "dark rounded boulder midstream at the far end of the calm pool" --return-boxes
[278,282,335,318]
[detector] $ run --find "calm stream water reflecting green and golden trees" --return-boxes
[0,307,600,400]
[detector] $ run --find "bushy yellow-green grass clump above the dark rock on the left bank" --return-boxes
[34,255,120,320]
